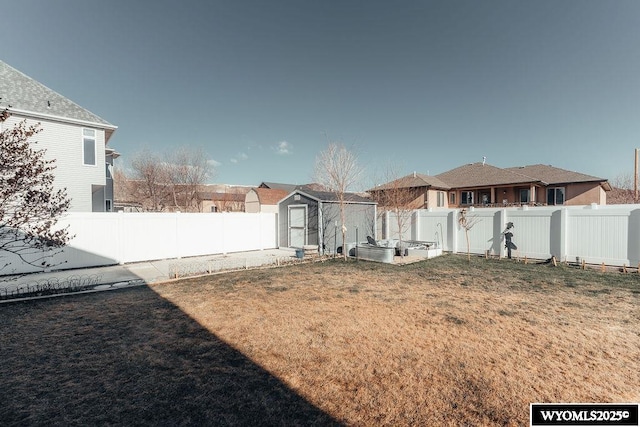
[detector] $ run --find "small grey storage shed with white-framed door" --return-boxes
[278,189,376,254]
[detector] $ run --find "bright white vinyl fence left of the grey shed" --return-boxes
[0,212,277,274]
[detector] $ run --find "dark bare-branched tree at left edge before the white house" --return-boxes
[0,110,71,270]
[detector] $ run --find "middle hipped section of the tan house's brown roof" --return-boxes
[436,162,540,188]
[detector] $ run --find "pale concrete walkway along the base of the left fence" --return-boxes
[0,249,296,300]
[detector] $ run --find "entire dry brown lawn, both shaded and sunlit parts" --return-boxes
[0,256,640,426]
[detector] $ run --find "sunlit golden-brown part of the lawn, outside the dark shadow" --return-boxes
[153,256,640,425]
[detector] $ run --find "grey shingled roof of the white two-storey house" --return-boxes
[0,61,117,130]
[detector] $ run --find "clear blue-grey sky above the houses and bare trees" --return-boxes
[0,0,640,187]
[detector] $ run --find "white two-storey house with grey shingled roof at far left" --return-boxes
[0,61,118,212]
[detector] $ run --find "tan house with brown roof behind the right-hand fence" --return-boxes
[369,162,611,208]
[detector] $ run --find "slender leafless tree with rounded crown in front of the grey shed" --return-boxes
[315,142,362,259]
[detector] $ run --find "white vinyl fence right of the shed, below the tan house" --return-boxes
[379,205,640,266]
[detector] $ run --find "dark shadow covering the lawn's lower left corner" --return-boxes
[0,287,338,426]
